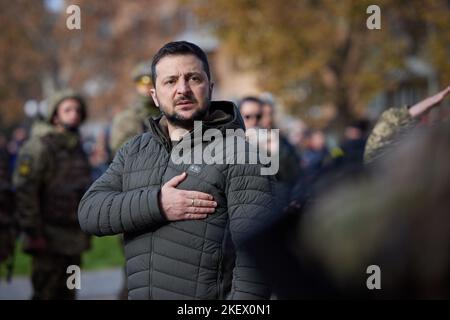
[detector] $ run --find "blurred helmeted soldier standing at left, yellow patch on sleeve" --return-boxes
[13,90,91,299]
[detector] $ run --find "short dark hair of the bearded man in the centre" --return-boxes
[152,41,211,86]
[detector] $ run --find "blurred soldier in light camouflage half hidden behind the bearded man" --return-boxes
[109,63,159,153]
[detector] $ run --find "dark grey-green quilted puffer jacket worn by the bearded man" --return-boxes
[78,101,274,299]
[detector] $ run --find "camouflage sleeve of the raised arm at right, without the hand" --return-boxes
[364,107,417,163]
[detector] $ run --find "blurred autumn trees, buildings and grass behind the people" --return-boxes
[0,0,450,300]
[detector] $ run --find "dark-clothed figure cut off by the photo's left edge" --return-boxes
[0,149,15,263]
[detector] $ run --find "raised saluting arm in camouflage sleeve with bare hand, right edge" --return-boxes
[364,86,450,163]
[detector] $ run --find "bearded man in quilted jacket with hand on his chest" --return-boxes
[78,41,273,299]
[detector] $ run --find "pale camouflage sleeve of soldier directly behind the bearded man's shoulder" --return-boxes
[109,110,142,154]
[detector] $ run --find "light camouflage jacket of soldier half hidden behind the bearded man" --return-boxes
[109,97,159,154]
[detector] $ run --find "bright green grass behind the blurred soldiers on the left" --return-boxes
[6,236,125,276]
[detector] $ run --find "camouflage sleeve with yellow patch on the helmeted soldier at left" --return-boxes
[13,138,49,236]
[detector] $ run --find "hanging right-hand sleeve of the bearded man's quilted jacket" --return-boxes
[226,158,274,300]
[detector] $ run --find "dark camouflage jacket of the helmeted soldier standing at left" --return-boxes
[13,123,91,255]
